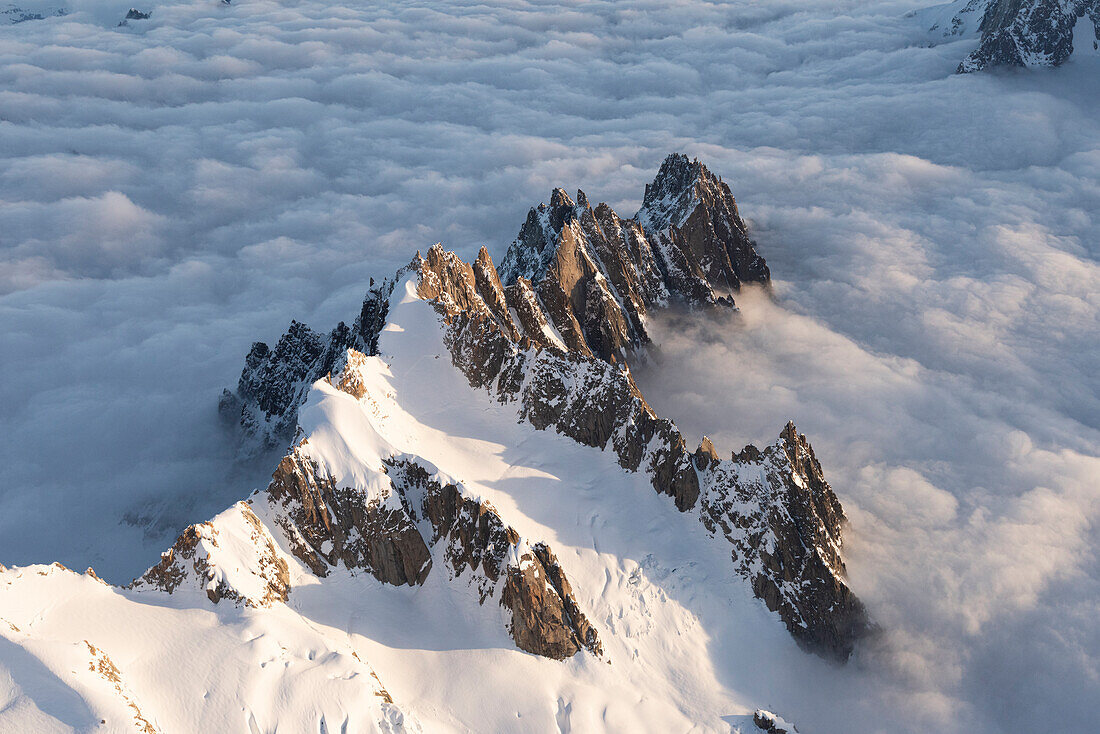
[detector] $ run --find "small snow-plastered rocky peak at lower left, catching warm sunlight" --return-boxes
[130,502,290,606]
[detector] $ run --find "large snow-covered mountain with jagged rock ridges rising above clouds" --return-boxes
[0,155,858,732]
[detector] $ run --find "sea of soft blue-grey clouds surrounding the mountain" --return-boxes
[0,0,1100,733]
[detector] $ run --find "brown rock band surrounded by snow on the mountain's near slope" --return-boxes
[254,413,601,659]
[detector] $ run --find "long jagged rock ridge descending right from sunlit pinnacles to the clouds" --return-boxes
[410,245,868,660]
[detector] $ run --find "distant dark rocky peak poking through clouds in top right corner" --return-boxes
[953,0,1100,73]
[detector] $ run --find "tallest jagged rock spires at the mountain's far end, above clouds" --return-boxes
[501,154,770,362]
